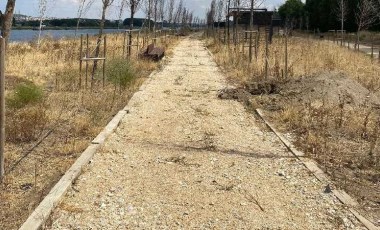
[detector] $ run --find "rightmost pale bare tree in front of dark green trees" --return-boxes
[355,0,378,49]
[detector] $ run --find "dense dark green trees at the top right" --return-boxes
[279,0,380,32]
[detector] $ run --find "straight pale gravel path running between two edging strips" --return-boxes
[50,35,362,229]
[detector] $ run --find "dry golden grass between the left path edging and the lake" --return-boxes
[0,31,177,229]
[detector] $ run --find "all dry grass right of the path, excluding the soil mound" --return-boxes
[206,29,380,223]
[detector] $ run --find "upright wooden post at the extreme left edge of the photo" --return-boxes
[0,38,5,181]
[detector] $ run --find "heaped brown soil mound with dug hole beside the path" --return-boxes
[218,72,380,108]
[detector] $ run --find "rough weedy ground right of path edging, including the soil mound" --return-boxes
[219,72,380,226]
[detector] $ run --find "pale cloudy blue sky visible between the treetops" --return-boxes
[0,0,285,19]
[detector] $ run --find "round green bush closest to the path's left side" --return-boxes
[106,59,136,89]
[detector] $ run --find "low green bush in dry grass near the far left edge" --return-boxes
[7,83,43,109]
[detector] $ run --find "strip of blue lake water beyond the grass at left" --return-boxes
[9,29,118,42]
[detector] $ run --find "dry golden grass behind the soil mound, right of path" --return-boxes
[206,31,380,90]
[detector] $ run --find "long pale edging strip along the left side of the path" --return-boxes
[19,67,165,230]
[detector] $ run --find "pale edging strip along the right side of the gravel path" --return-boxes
[256,109,380,230]
